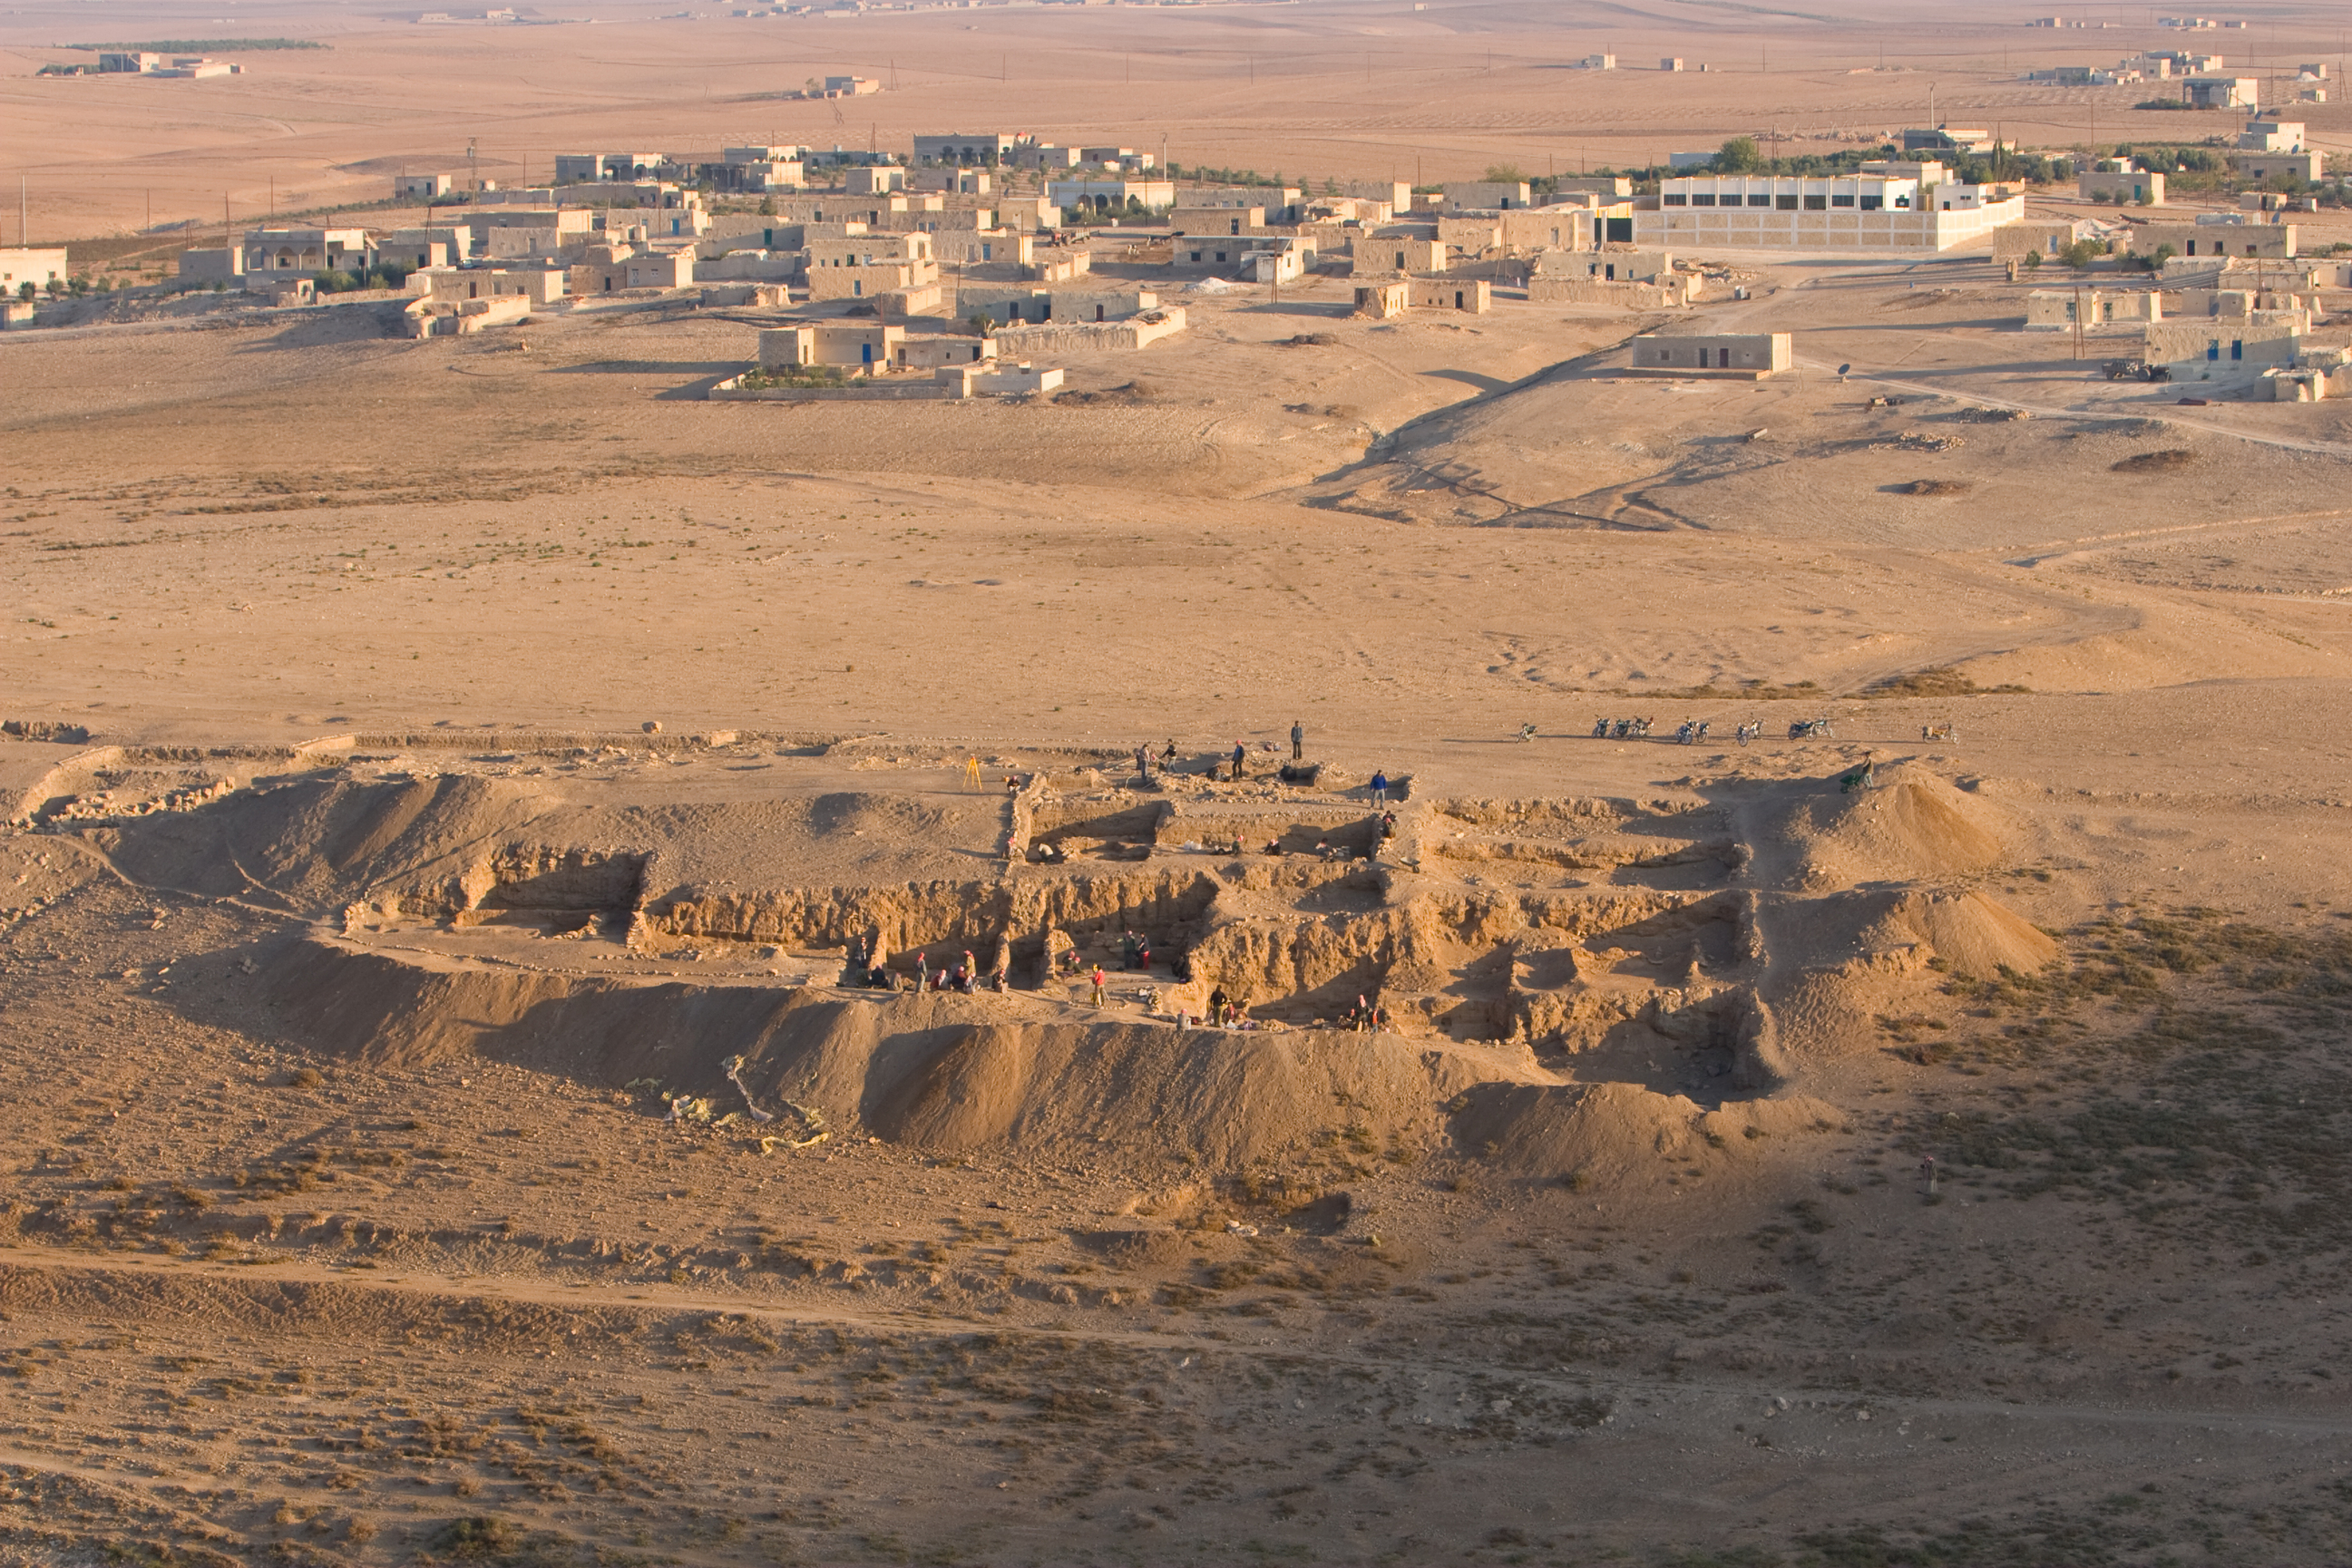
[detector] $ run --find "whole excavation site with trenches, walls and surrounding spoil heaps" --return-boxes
[63,753,2051,1175]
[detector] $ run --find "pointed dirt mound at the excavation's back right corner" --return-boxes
[1788,764,2006,886]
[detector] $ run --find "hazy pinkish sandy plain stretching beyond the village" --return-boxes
[0,0,2352,242]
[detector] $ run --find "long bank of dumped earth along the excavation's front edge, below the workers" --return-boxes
[263,938,1552,1164]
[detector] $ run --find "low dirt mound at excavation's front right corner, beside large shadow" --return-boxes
[1453,1084,1844,1192]
